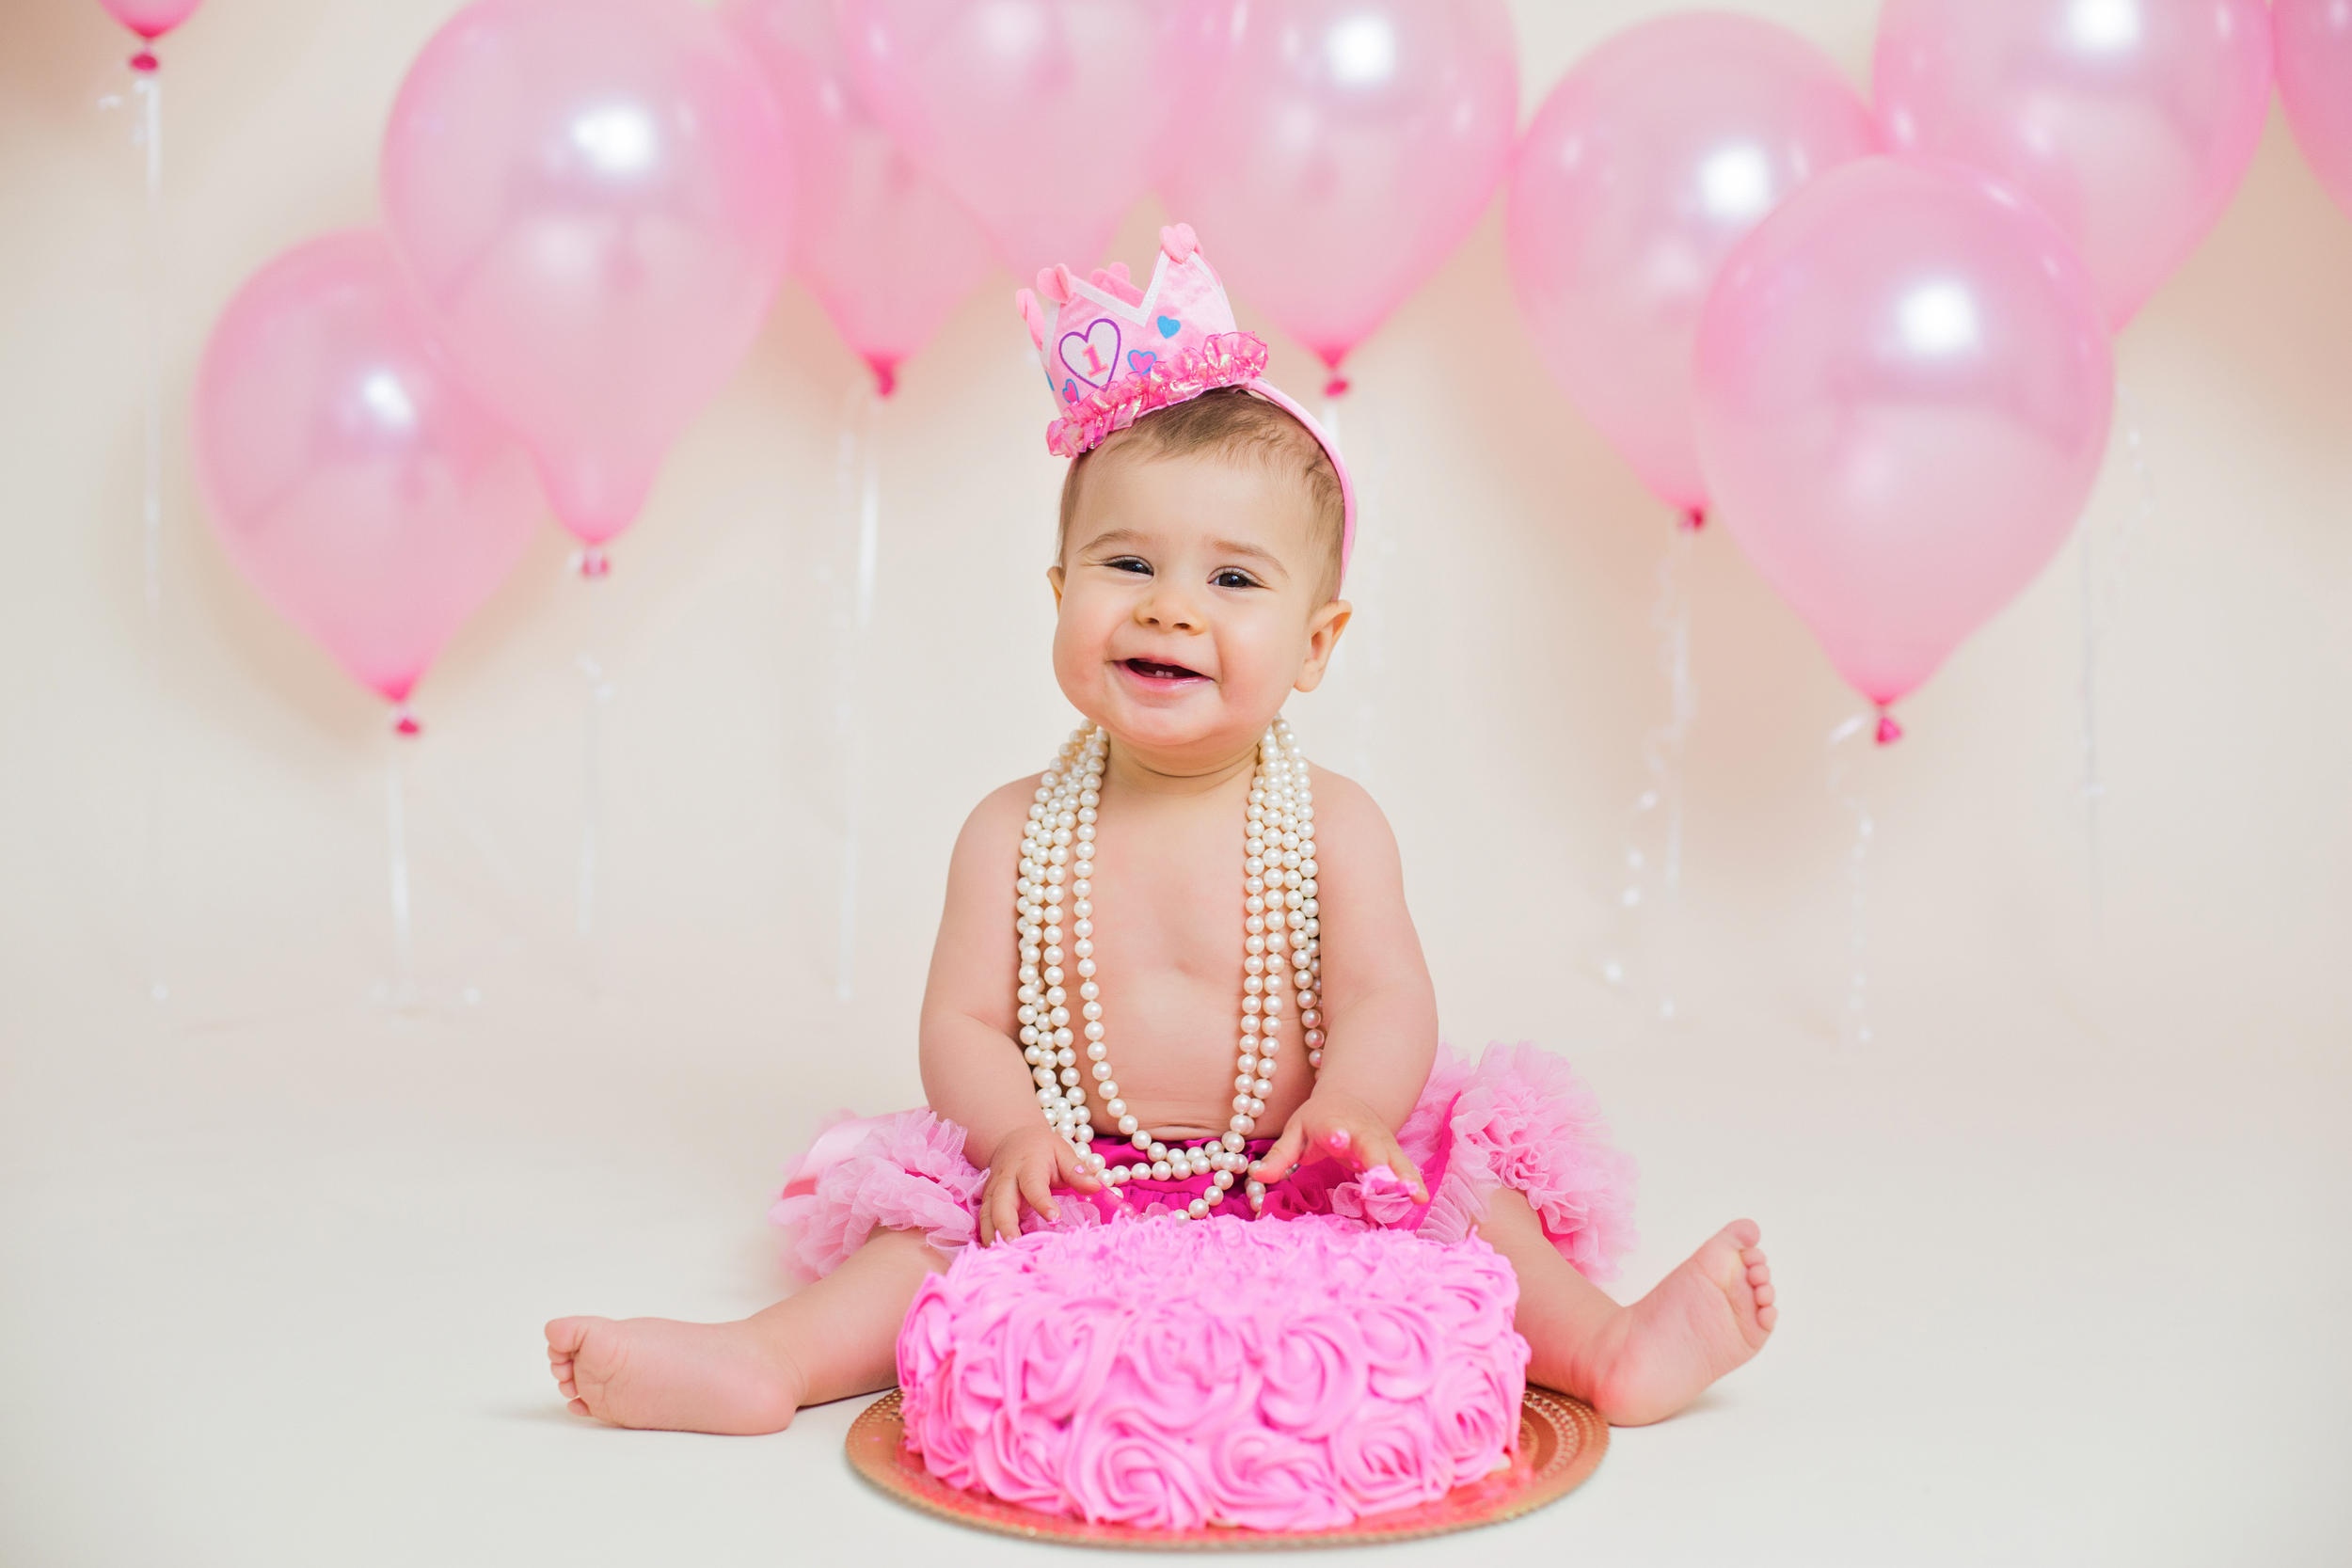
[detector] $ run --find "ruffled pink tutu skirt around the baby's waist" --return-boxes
[770,1046,1632,1279]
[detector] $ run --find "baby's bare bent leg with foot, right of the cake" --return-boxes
[1480,1187,1781,1427]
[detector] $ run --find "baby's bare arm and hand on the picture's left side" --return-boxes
[922,778,1096,1243]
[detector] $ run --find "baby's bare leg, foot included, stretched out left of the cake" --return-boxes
[548,1229,948,1434]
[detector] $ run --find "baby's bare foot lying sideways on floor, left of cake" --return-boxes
[548,1317,807,1436]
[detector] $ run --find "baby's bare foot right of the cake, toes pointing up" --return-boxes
[1593,1220,1781,1427]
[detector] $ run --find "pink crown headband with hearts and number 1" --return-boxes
[1014,223,1355,571]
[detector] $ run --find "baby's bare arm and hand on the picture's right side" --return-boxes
[1251,768,1438,1199]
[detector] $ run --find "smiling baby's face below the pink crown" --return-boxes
[1047,451,1348,764]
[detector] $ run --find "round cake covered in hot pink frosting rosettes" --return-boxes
[898,1215,1527,1530]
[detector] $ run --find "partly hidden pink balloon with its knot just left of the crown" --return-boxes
[720,0,995,395]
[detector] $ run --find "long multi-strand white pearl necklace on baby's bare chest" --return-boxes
[1014,720,1325,1220]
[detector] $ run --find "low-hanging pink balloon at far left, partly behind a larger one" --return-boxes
[196,228,541,703]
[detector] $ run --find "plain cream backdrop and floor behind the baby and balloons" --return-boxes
[0,0,2352,1566]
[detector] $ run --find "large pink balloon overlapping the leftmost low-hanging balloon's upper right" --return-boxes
[384,0,790,546]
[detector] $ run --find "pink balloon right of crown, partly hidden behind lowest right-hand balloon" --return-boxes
[1505,11,1877,515]
